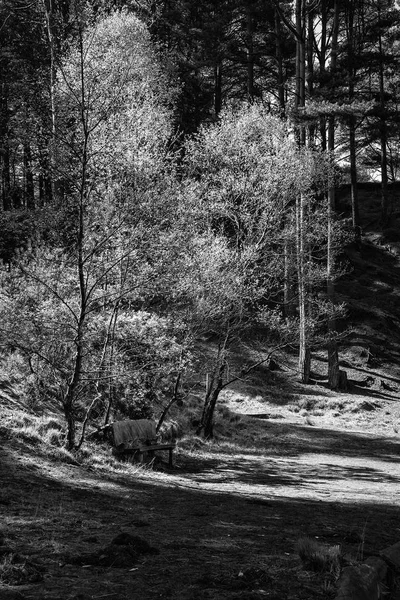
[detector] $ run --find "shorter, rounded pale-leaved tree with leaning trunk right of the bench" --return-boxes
[180,104,342,435]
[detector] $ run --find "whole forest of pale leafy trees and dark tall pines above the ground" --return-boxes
[0,0,400,450]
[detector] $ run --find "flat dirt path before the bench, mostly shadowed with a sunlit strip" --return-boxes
[0,422,400,600]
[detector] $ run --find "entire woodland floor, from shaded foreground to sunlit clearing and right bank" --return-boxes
[0,185,400,600]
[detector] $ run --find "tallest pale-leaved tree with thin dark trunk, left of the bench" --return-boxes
[3,10,180,449]
